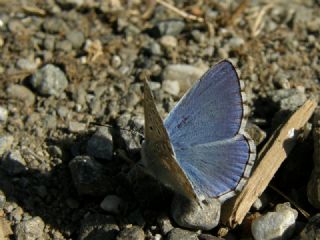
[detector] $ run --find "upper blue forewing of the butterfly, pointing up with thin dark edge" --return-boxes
[164,61,244,146]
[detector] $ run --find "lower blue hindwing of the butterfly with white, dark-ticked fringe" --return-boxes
[175,135,253,198]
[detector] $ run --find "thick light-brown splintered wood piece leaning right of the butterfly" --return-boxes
[221,100,317,227]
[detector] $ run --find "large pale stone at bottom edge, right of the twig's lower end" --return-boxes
[251,203,298,240]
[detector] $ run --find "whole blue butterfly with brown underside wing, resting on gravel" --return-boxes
[141,60,256,202]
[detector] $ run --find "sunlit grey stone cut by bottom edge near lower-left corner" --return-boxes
[14,217,44,240]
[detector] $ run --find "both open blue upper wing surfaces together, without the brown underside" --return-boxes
[164,61,255,199]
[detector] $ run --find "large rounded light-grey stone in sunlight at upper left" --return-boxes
[30,64,68,97]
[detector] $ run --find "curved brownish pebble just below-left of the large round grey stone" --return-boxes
[7,84,35,106]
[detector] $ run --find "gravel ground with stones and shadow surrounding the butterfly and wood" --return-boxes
[0,0,320,240]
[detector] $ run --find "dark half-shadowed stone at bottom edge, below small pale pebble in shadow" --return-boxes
[78,214,119,240]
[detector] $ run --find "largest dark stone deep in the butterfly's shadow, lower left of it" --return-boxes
[69,156,113,196]
